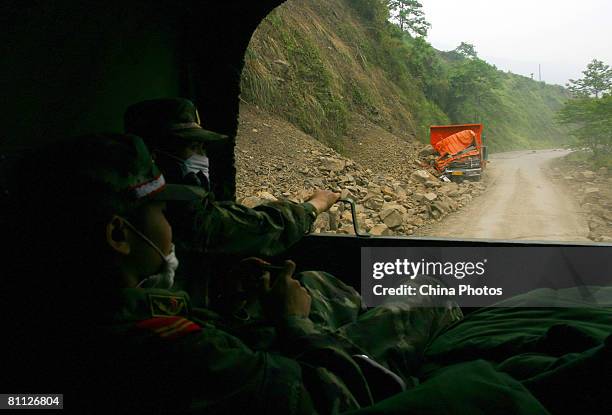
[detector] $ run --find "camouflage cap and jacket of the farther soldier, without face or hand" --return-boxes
[124,98,316,257]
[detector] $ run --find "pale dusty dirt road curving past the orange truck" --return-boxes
[419,150,589,242]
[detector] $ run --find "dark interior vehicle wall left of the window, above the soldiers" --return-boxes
[0,0,283,199]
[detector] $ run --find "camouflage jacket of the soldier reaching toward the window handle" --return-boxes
[156,157,317,257]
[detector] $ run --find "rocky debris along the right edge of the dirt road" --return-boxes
[549,158,612,243]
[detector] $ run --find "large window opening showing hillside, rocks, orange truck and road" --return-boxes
[235,0,612,244]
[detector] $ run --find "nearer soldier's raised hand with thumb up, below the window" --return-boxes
[263,261,311,320]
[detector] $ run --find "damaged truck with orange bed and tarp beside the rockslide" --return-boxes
[429,124,487,180]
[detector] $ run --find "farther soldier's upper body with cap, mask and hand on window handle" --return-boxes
[124,98,339,306]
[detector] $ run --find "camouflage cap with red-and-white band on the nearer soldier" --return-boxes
[75,134,203,200]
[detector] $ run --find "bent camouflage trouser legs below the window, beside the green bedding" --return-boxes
[297,271,463,384]
